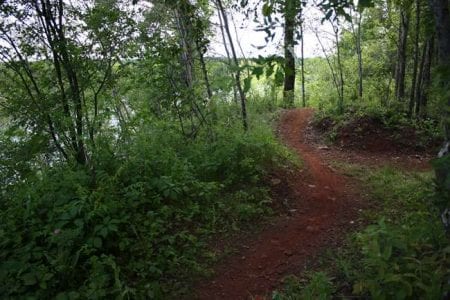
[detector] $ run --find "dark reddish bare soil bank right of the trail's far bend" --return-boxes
[312,117,439,171]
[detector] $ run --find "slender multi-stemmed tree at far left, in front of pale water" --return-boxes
[0,0,134,165]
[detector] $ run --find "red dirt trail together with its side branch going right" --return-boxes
[197,109,429,300]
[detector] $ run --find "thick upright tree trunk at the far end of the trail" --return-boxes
[283,0,297,107]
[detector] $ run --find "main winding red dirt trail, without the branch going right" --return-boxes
[197,109,362,300]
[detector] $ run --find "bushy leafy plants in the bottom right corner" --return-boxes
[353,217,450,299]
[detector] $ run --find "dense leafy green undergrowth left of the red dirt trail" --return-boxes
[0,103,291,299]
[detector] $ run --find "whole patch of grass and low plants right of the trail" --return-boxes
[273,165,450,299]
